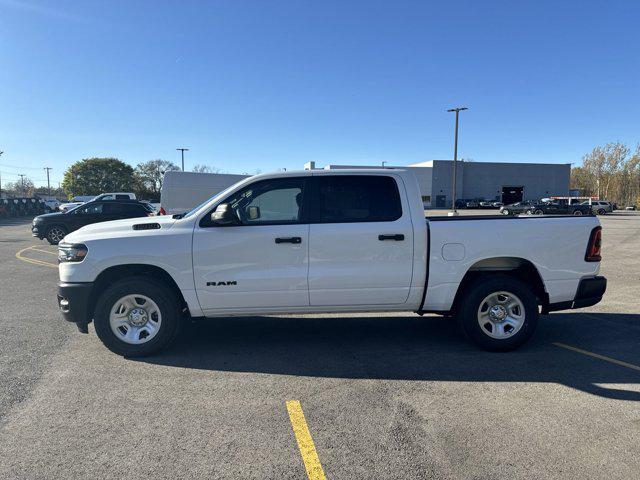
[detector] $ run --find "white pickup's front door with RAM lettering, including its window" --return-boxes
[193,177,309,313]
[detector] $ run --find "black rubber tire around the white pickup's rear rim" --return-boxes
[457,274,538,352]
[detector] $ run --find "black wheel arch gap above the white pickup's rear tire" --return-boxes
[451,257,549,313]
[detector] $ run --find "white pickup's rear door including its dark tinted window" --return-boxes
[309,174,413,306]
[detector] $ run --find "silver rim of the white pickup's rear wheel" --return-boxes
[478,291,526,340]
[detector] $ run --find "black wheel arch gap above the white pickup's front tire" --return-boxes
[88,263,188,318]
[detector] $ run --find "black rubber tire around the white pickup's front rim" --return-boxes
[93,277,182,357]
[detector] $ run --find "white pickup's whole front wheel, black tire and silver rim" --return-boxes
[94,277,180,357]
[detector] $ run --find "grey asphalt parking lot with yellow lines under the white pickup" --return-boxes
[0,212,640,479]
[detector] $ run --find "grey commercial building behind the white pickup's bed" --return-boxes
[316,160,571,208]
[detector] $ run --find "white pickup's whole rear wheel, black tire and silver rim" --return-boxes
[458,275,538,351]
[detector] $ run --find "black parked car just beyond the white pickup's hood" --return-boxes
[31,200,153,245]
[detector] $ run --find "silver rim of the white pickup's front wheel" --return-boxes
[109,293,162,345]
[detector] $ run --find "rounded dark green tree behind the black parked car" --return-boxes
[62,158,135,197]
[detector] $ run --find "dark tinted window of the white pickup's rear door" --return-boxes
[313,175,402,223]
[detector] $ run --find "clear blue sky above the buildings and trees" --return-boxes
[0,0,640,184]
